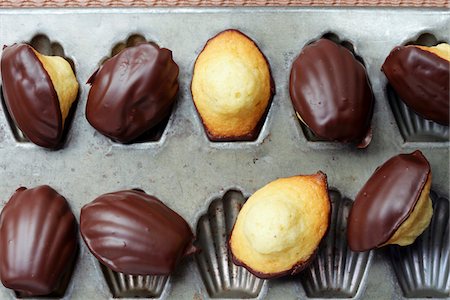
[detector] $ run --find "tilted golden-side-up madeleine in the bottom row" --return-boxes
[229,172,330,278]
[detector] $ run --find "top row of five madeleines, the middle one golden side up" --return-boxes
[1,30,450,148]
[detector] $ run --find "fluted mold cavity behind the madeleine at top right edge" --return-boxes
[386,33,449,142]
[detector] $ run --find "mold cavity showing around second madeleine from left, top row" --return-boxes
[99,34,173,144]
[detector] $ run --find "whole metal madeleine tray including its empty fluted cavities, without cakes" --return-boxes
[0,7,450,299]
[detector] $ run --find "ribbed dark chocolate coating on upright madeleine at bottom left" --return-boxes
[0,185,78,296]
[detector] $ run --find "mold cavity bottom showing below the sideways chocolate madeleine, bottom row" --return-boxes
[100,264,169,298]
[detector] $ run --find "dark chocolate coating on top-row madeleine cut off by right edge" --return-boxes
[382,45,450,126]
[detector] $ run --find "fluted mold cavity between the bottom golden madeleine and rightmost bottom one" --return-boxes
[300,190,371,298]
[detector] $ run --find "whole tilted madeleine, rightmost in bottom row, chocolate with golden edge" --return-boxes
[347,150,433,251]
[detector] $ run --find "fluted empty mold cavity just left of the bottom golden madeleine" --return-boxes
[195,190,264,298]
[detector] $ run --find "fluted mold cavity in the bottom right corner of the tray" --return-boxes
[389,191,450,298]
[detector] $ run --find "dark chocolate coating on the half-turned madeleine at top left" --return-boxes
[1,44,63,148]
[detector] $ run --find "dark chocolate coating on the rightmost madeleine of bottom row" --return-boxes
[347,150,431,251]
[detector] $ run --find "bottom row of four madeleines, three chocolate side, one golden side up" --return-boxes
[0,150,433,296]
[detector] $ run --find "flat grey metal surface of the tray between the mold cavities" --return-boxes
[0,8,450,299]
